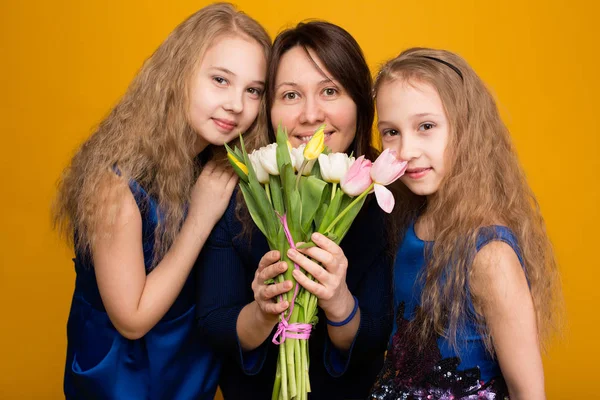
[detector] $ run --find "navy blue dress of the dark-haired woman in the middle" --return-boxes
[197,194,392,400]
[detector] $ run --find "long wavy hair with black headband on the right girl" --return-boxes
[374,48,562,353]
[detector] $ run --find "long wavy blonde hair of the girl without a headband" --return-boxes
[53,3,271,266]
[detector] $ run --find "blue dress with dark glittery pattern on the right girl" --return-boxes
[370,224,523,400]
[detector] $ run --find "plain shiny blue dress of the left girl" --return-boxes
[64,181,220,400]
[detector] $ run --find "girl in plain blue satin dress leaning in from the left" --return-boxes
[55,3,271,399]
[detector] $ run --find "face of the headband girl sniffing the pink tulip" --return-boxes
[377,79,450,196]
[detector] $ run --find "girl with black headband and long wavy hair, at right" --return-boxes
[372,48,561,399]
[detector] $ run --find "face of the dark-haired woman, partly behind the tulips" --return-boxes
[271,46,356,152]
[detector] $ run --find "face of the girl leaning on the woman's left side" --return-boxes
[188,36,267,153]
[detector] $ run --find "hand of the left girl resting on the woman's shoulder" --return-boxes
[189,161,238,225]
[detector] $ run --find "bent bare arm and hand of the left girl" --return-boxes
[92,163,237,339]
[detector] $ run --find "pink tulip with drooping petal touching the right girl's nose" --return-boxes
[371,149,407,214]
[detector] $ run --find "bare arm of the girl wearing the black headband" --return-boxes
[470,242,546,400]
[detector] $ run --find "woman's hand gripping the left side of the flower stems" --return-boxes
[252,250,292,325]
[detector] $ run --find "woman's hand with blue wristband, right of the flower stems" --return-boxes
[288,233,354,321]
